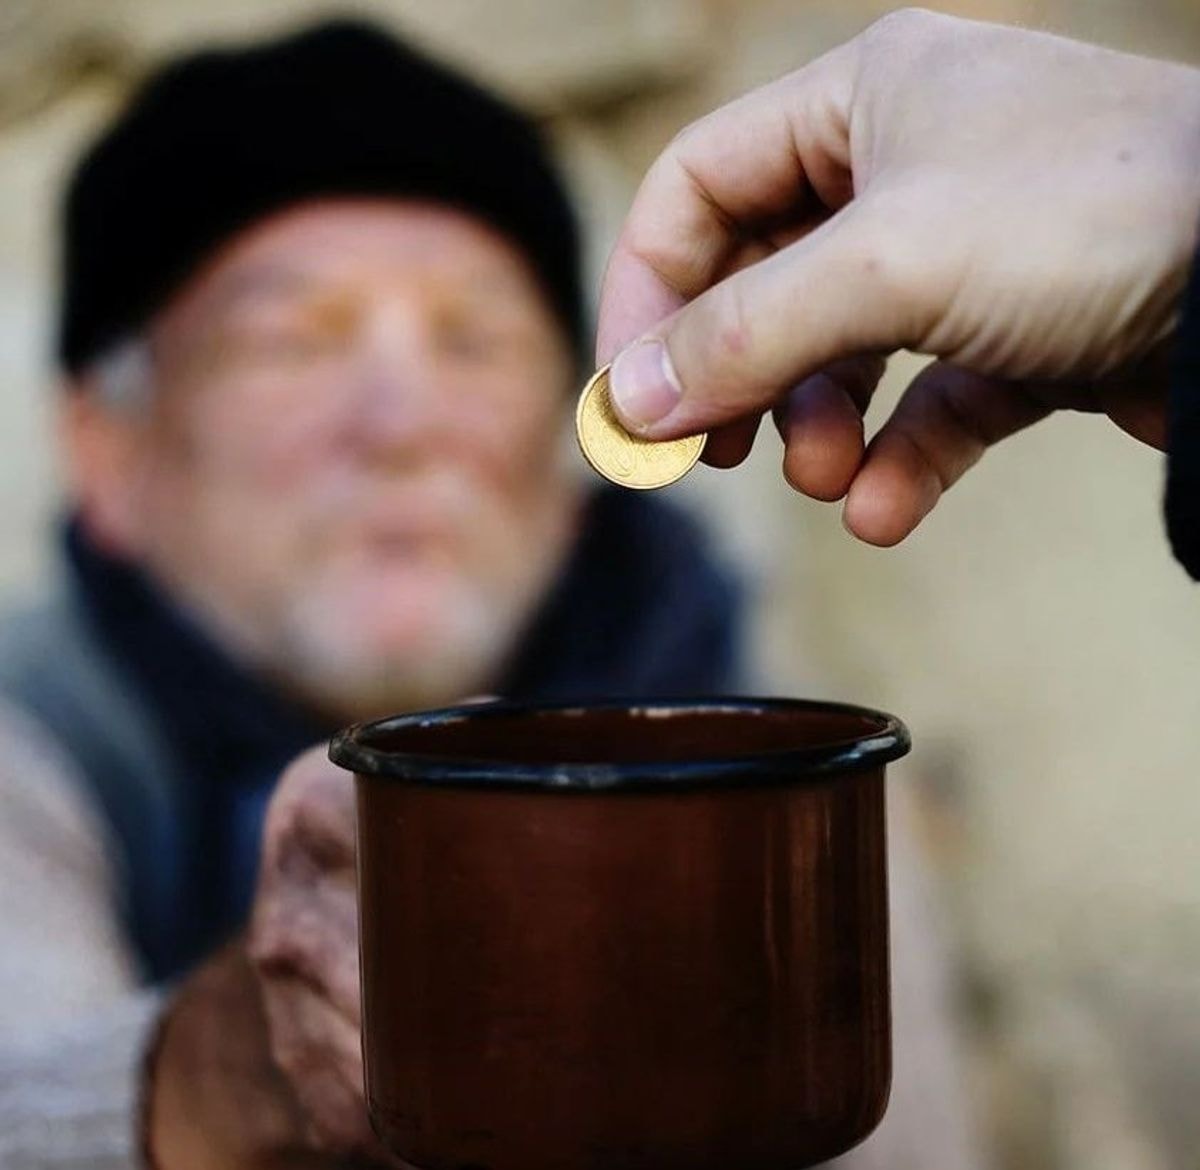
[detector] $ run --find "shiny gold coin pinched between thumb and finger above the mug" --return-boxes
[575,366,708,490]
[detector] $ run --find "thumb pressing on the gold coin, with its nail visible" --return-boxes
[610,204,934,439]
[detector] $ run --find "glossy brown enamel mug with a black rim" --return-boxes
[330,700,908,1170]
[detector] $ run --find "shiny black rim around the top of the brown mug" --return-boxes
[329,696,912,792]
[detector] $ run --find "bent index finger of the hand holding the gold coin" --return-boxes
[596,42,853,365]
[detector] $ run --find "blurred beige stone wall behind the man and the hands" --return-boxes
[0,0,1200,1170]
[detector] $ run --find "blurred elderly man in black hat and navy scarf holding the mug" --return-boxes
[0,24,974,1170]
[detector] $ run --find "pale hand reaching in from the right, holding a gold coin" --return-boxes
[598,11,1200,545]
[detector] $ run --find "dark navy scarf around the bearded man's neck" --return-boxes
[67,490,738,978]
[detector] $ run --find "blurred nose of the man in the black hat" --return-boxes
[347,296,445,458]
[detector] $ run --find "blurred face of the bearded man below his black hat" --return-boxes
[78,202,574,718]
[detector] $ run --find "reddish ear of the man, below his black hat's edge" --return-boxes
[59,376,146,559]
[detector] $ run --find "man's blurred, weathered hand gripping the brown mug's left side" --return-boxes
[148,749,386,1170]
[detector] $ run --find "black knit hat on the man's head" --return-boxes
[59,20,584,372]
